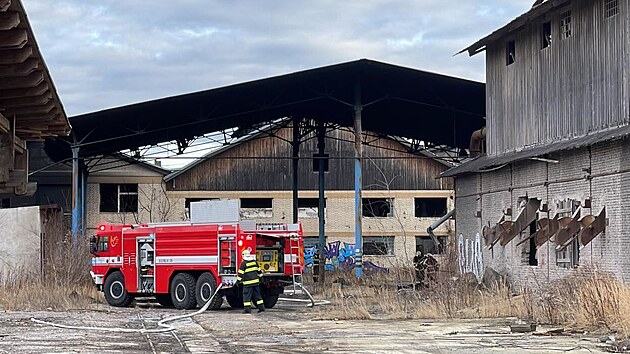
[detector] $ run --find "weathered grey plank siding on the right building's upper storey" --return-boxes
[487,0,630,155]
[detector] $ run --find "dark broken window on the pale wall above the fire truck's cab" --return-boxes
[99,183,138,213]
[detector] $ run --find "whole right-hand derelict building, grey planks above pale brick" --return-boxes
[442,0,630,285]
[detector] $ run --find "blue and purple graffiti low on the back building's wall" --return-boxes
[304,241,387,272]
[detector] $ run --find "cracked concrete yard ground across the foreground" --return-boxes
[0,302,606,353]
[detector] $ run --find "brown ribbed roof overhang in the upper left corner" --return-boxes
[0,0,70,140]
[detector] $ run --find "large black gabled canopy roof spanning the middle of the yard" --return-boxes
[47,59,485,160]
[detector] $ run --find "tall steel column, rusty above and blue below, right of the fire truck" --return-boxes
[354,82,363,278]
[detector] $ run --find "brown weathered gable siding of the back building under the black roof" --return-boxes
[168,128,453,191]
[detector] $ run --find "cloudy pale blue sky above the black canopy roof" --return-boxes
[23,0,533,116]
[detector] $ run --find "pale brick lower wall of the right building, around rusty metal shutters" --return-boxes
[455,140,630,286]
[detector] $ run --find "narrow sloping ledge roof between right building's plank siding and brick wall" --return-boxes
[440,126,630,177]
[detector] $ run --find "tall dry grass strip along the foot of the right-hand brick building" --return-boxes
[312,271,630,336]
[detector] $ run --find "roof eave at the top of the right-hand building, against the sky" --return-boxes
[457,0,571,56]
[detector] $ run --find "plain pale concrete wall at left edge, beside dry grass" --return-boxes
[0,206,41,278]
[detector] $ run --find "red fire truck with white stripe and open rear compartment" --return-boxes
[90,222,304,309]
